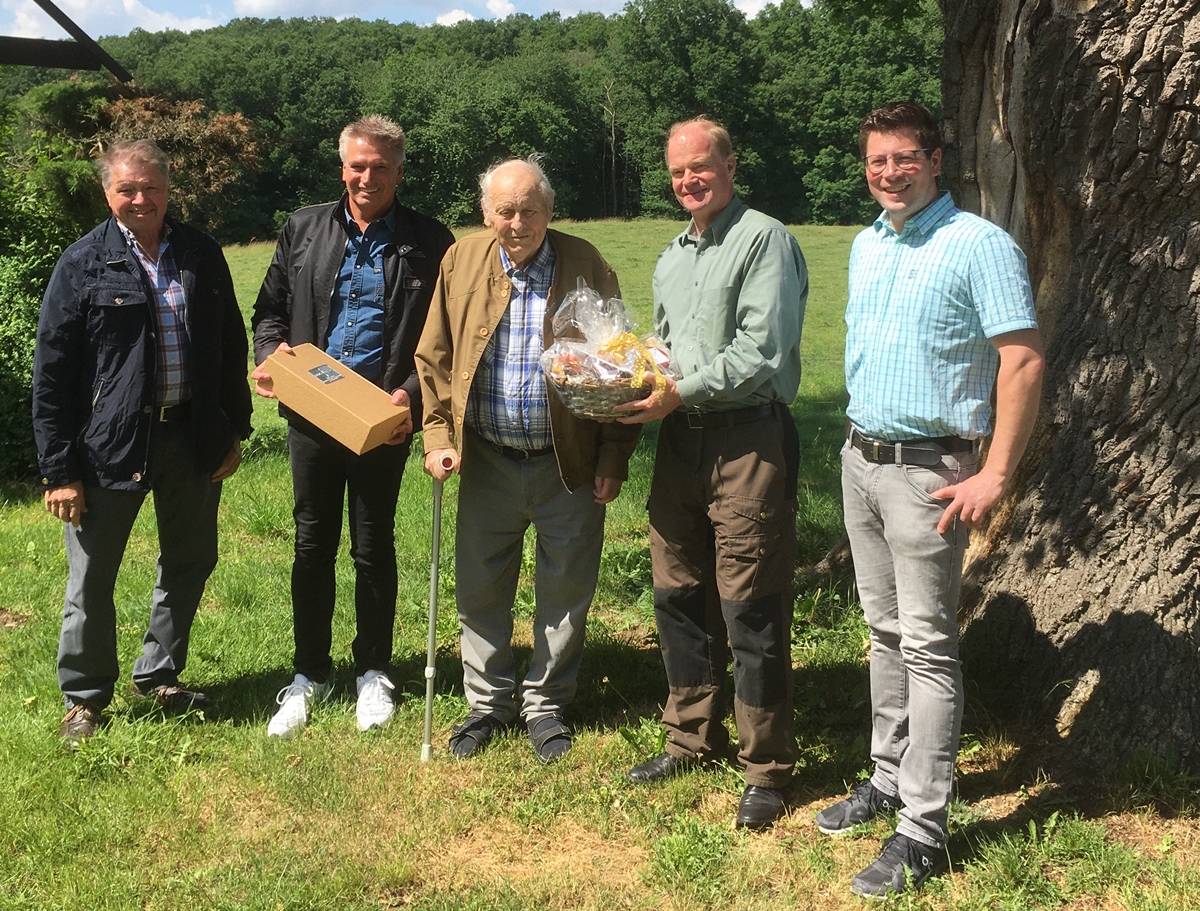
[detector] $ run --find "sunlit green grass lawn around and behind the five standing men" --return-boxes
[0,221,1200,911]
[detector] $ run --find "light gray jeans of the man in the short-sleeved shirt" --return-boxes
[841,444,976,847]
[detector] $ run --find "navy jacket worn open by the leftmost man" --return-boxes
[34,218,251,490]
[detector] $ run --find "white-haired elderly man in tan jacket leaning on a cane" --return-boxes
[416,158,638,762]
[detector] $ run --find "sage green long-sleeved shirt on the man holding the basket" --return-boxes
[654,197,809,412]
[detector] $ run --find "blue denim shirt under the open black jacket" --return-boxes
[325,205,396,380]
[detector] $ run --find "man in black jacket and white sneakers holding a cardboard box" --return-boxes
[252,116,454,737]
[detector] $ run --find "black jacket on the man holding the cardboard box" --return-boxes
[251,196,454,430]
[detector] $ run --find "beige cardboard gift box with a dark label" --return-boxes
[264,344,408,455]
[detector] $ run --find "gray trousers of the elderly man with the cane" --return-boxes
[455,434,605,721]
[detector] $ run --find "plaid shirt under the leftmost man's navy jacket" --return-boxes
[118,222,192,406]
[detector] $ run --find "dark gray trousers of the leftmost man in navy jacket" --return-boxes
[59,421,221,708]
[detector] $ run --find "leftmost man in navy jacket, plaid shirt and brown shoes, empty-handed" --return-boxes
[34,139,251,747]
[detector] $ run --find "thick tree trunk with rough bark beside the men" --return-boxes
[942,0,1200,769]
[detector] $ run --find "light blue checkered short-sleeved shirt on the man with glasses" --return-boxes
[846,193,1038,440]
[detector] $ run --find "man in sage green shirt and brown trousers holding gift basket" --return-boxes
[622,119,808,828]
